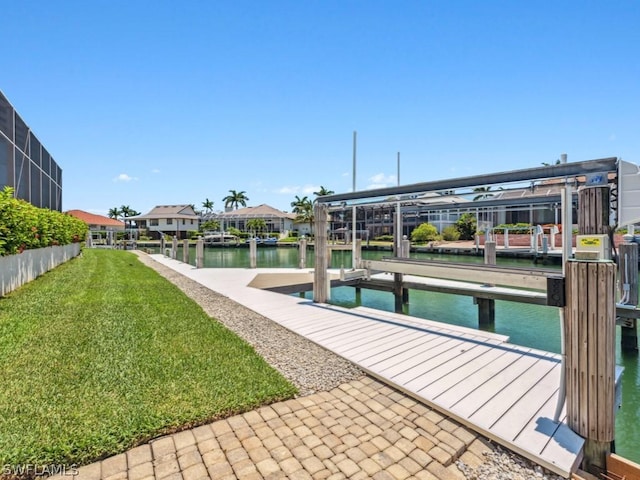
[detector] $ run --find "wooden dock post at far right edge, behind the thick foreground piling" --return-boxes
[618,242,638,353]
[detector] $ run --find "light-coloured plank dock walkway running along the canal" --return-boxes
[152,255,584,477]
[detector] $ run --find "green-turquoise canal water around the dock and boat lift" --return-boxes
[152,247,640,463]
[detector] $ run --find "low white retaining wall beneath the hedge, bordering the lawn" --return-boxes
[0,243,80,297]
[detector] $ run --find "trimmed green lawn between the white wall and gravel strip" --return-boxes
[0,250,295,465]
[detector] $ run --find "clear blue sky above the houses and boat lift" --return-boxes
[0,0,640,214]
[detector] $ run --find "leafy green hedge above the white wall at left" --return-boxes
[0,187,88,256]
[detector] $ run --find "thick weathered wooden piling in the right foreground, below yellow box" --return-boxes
[564,261,616,475]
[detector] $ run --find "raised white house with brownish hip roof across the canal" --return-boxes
[127,205,200,239]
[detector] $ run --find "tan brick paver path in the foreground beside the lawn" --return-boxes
[50,377,500,480]
